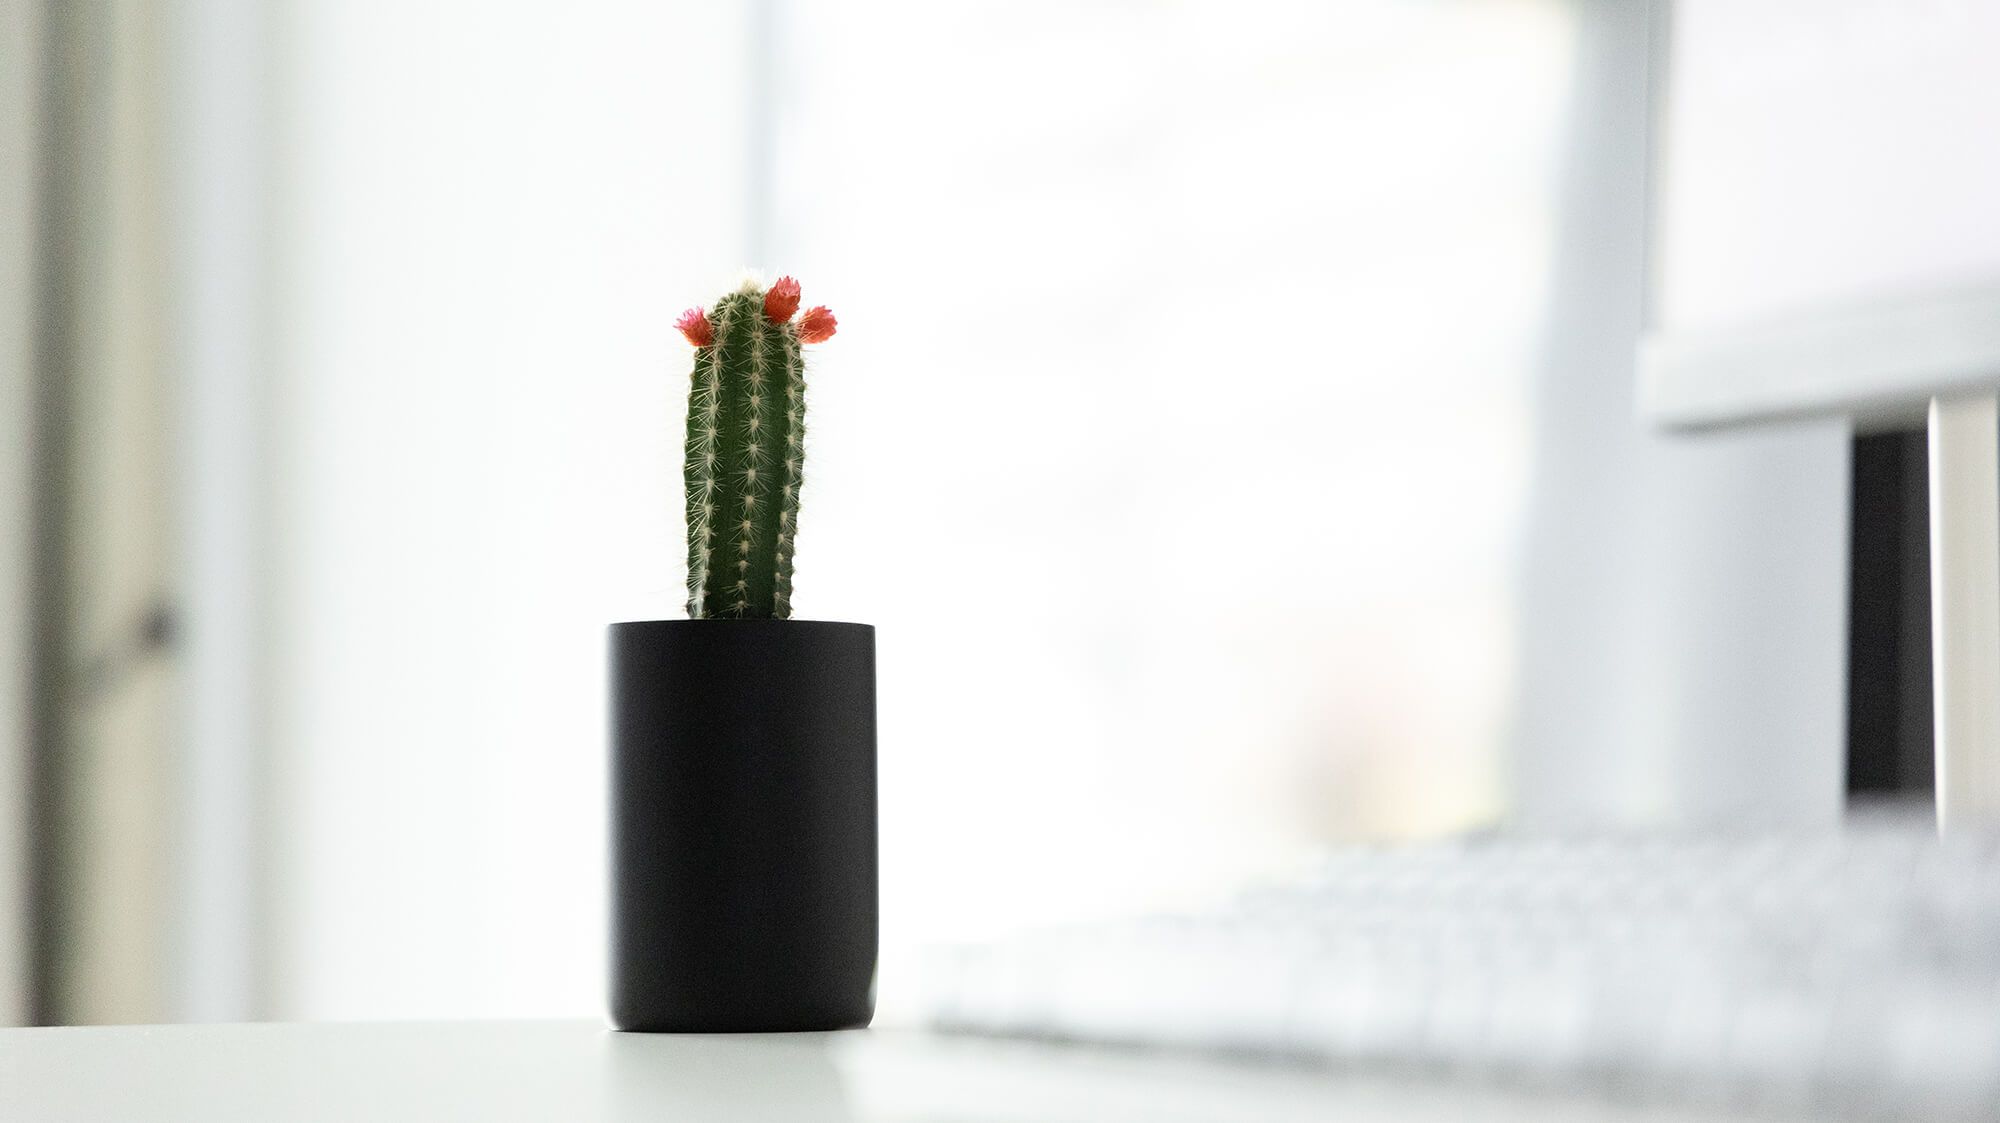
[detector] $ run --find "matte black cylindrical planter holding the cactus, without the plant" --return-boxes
[610,619,876,1033]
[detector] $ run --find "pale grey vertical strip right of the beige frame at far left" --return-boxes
[162,0,284,1021]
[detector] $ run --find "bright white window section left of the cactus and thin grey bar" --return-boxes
[274,0,752,1017]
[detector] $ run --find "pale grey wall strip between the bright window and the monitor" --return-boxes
[1508,0,1848,829]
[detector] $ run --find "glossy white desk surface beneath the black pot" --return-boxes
[0,1021,1768,1123]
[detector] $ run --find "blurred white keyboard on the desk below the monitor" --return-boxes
[922,815,2000,1119]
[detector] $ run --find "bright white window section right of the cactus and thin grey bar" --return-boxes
[774,0,1572,979]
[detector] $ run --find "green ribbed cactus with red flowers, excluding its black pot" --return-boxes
[674,278,834,619]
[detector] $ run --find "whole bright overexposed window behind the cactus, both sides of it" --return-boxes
[276,0,1572,1017]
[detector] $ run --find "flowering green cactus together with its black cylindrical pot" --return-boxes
[610,278,876,1033]
